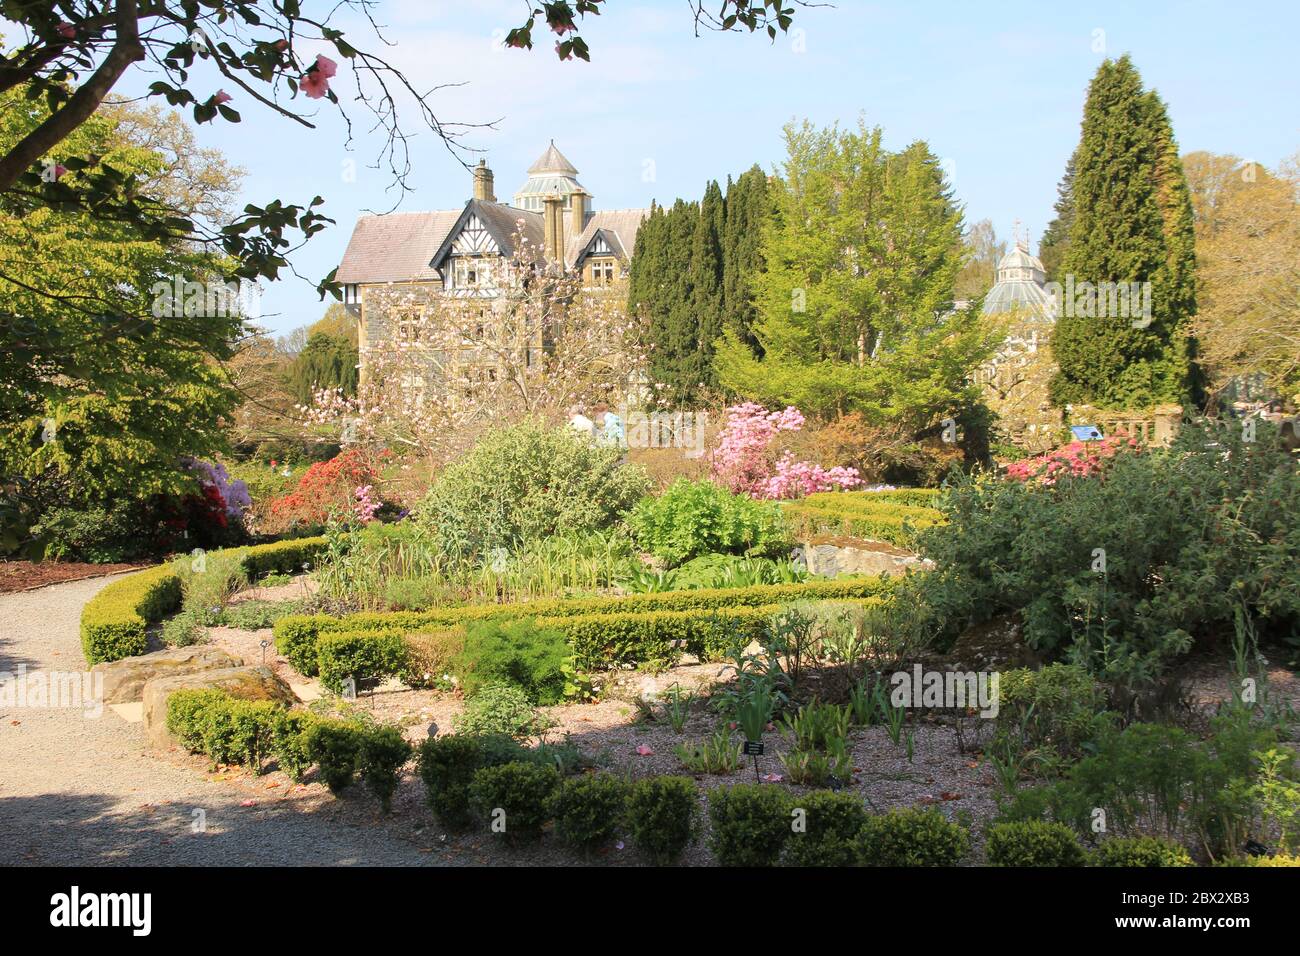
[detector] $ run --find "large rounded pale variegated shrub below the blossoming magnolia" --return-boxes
[416,421,649,559]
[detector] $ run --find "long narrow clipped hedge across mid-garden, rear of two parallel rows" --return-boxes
[274,578,894,676]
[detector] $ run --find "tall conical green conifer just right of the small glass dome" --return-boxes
[1052,56,1196,408]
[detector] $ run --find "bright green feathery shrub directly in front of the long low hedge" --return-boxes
[456,618,573,706]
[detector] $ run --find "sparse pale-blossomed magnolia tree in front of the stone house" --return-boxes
[300,228,645,463]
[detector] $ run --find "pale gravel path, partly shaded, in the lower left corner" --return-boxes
[0,579,452,866]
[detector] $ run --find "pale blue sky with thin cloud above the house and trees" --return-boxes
[122,0,1300,333]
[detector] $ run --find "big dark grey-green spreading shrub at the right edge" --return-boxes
[922,420,1300,693]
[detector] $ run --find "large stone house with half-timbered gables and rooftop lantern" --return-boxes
[335,140,649,392]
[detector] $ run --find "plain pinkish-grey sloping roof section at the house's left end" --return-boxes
[335,209,460,285]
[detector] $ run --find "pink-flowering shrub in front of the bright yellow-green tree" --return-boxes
[711,402,862,499]
